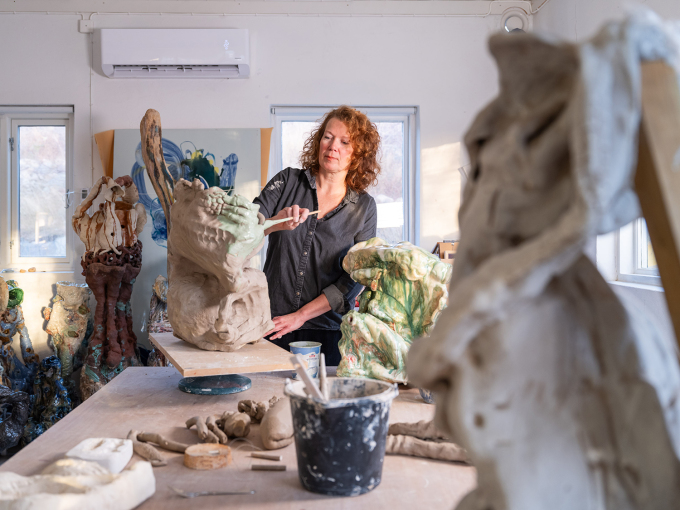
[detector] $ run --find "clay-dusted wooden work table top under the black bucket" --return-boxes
[0,367,476,510]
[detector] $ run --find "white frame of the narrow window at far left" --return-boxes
[0,106,75,271]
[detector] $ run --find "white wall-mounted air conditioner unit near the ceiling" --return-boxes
[100,28,250,78]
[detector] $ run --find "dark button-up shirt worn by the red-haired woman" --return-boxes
[253,168,378,330]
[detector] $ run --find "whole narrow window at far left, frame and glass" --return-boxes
[0,106,73,270]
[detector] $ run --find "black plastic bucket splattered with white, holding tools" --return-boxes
[284,377,399,496]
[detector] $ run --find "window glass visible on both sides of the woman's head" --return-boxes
[281,121,406,243]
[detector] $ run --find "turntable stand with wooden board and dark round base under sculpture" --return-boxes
[149,333,293,395]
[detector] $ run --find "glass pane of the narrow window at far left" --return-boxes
[17,126,66,257]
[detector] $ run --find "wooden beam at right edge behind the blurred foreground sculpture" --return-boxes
[635,62,680,352]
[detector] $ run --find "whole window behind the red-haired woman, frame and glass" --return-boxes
[269,106,418,244]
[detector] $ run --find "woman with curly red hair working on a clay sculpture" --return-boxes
[254,106,380,366]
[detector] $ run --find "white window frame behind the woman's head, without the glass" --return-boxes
[267,105,420,245]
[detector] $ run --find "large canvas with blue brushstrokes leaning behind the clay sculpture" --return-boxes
[113,129,271,346]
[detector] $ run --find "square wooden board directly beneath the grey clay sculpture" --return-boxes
[149,333,293,377]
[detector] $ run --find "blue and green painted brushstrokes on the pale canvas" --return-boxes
[130,138,238,248]
